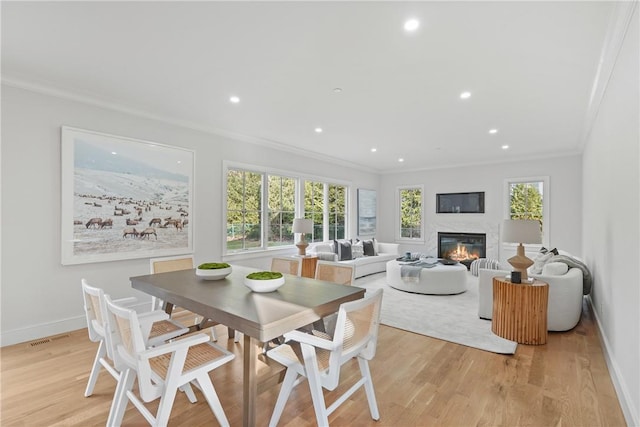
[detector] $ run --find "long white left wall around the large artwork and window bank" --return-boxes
[0,85,378,345]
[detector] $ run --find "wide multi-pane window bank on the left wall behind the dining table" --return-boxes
[225,164,349,253]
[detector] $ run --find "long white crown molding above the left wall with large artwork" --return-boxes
[2,75,381,173]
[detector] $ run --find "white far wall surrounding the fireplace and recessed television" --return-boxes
[379,152,582,262]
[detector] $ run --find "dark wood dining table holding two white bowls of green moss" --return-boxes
[130,265,365,426]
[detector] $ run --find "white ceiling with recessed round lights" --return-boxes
[2,1,615,172]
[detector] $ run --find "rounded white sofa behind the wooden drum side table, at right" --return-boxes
[478,268,583,331]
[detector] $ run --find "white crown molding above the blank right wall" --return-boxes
[579,1,638,149]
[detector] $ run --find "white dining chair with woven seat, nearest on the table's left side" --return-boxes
[105,296,235,426]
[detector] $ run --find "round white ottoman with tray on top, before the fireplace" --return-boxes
[387,260,467,295]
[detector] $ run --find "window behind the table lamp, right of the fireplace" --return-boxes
[505,177,549,244]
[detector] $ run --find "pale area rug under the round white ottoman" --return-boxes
[354,273,517,354]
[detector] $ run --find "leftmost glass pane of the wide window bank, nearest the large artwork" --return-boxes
[227,170,262,251]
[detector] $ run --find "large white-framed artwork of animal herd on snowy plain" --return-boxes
[61,126,195,265]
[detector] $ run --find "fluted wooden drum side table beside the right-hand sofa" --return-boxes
[491,277,549,345]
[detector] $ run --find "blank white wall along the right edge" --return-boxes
[582,7,640,426]
